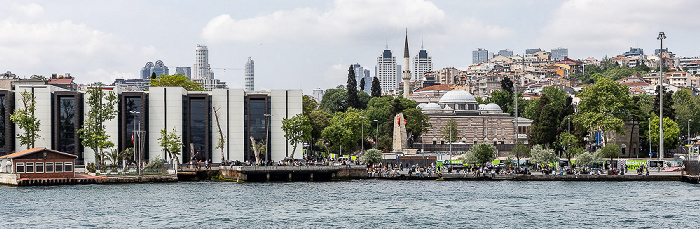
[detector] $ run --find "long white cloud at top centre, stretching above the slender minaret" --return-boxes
[202,0,445,43]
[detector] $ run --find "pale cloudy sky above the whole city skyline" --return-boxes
[0,0,700,94]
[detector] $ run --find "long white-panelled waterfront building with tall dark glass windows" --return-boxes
[0,85,303,165]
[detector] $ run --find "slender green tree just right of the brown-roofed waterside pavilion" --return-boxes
[78,83,119,165]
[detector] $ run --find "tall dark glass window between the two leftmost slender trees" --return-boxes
[58,96,76,154]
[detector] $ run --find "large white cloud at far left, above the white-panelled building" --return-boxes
[0,4,145,83]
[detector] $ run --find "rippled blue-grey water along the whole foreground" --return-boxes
[0,180,700,228]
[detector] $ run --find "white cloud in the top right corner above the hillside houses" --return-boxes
[537,0,700,57]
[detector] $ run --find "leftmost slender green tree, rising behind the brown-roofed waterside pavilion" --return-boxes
[10,91,41,149]
